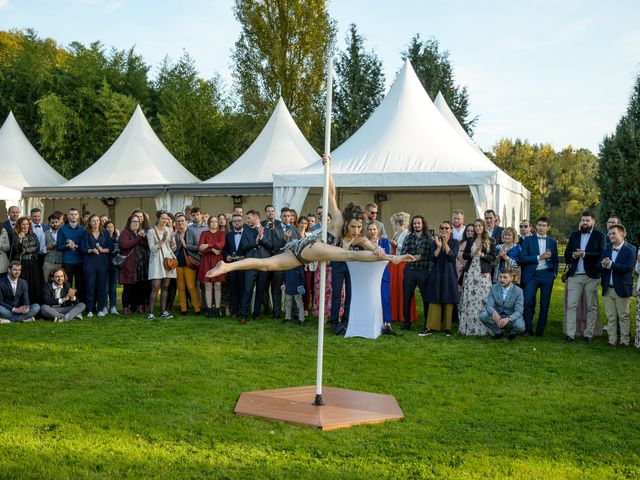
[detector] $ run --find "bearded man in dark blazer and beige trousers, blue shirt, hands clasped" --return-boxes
[564,212,605,342]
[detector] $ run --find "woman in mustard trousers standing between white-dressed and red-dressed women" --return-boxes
[176,213,201,317]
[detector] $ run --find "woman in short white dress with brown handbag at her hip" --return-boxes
[147,210,178,320]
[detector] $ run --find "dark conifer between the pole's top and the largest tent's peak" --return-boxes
[331,23,384,147]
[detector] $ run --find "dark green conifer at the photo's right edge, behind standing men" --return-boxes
[597,75,640,245]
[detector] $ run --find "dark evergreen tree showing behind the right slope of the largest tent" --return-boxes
[402,34,478,136]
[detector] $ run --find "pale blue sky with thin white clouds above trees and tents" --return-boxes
[0,0,640,153]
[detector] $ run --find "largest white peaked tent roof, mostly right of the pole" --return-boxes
[273,61,499,187]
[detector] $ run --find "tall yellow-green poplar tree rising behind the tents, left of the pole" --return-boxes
[232,0,335,142]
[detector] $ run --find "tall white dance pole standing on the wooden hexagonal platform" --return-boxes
[313,55,333,406]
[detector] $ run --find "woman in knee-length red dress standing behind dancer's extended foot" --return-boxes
[198,215,225,318]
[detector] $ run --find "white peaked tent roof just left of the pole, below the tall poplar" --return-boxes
[203,97,319,184]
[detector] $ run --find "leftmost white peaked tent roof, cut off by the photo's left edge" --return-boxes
[0,112,65,190]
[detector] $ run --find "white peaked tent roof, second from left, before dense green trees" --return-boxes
[63,105,200,188]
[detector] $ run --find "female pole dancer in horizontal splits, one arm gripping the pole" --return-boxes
[207,157,414,278]
